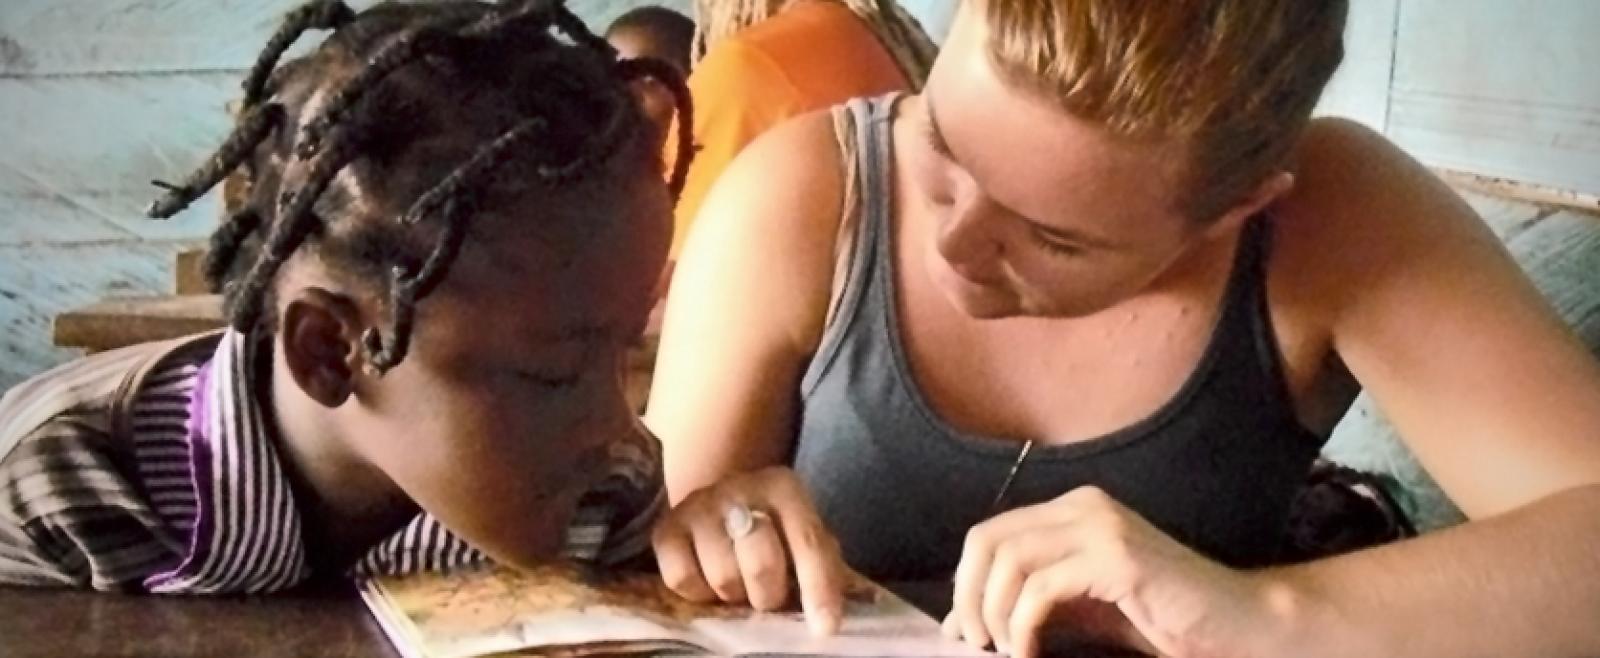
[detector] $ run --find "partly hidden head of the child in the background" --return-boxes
[605,6,694,140]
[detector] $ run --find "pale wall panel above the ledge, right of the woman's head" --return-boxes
[1322,0,1600,195]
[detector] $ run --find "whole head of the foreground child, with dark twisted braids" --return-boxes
[152,2,694,565]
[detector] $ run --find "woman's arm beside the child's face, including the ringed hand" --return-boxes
[645,112,848,632]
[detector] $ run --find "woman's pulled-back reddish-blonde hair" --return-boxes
[970,0,1347,219]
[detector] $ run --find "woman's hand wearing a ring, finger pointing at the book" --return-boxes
[651,466,850,634]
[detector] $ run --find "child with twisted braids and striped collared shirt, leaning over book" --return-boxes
[0,2,840,627]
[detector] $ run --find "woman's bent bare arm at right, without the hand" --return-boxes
[1248,123,1600,656]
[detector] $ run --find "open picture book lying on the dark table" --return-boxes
[360,565,989,658]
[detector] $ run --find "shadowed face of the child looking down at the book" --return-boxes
[344,149,672,564]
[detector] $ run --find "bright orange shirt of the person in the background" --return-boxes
[667,0,934,258]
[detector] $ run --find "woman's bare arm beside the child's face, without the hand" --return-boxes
[645,112,842,503]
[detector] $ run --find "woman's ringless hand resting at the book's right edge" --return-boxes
[944,487,1269,658]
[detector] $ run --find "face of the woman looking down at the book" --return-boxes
[901,3,1198,317]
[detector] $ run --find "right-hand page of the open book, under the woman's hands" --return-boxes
[690,581,994,658]
